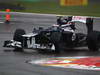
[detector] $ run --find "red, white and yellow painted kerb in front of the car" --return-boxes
[29,57,100,71]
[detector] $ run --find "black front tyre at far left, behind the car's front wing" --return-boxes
[13,29,26,51]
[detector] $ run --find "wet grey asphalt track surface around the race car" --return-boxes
[0,12,100,75]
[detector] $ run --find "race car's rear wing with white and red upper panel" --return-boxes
[68,16,93,34]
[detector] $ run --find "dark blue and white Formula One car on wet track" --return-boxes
[4,16,100,53]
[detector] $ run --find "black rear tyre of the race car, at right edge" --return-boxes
[87,31,100,51]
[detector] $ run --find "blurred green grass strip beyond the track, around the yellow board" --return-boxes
[13,2,100,17]
